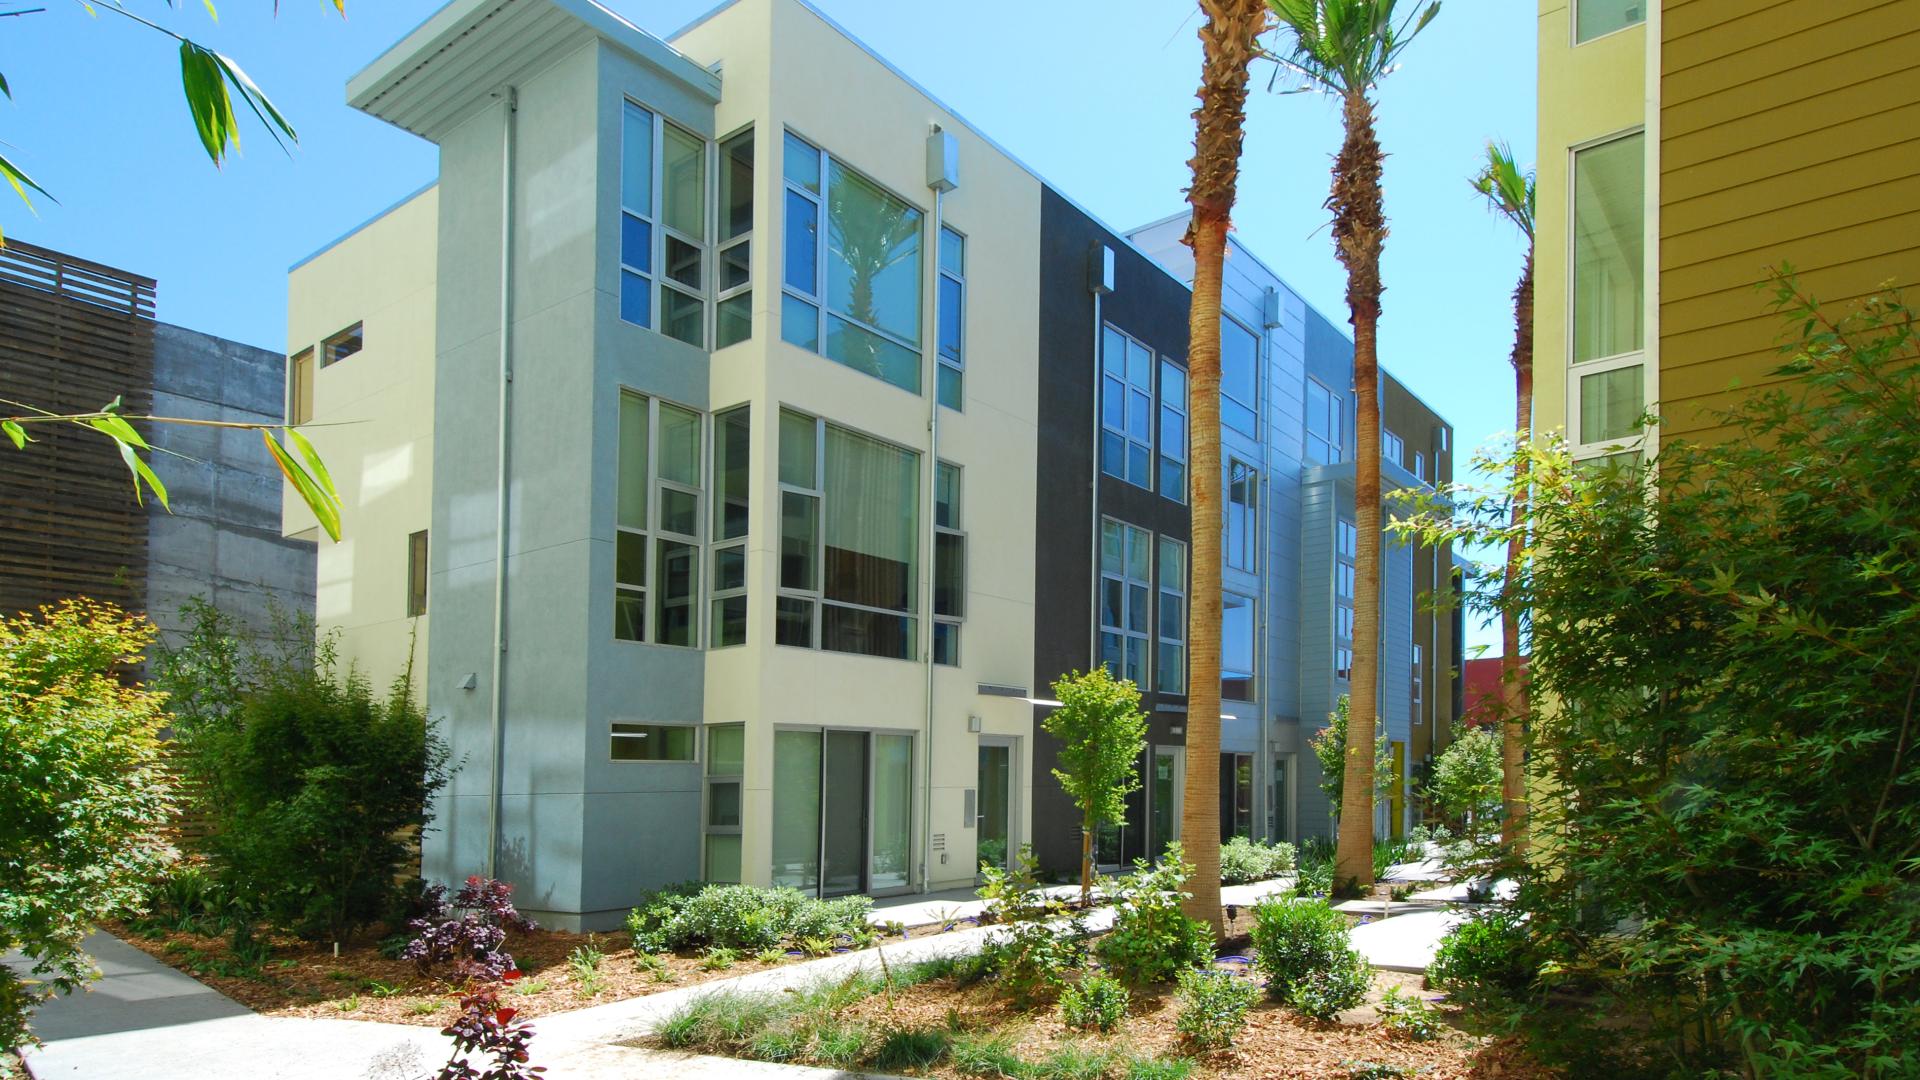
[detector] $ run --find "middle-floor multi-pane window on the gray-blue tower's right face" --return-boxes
[614,392,703,648]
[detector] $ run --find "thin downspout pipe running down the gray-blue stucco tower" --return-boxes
[486,86,520,878]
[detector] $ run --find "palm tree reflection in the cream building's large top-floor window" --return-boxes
[828,173,920,379]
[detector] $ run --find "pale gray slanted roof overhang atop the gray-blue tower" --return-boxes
[348,0,720,140]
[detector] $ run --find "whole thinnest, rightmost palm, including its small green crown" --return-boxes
[1471,142,1534,857]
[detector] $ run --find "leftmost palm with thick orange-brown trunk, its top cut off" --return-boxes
[1181,0,1267,938]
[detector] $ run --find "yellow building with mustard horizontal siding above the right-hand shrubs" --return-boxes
[1534,0,1920,457]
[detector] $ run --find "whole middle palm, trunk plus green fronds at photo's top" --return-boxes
[1267,0,1440,888]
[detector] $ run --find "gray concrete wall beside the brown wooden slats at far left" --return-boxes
[146,323,313,644]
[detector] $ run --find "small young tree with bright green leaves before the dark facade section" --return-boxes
[1041,667,1146,905]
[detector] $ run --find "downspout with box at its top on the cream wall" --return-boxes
[920,123,960,892]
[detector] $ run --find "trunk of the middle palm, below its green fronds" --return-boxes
[1327,88,1386,888]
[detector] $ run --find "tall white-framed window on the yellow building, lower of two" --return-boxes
[1571,133,1645,448]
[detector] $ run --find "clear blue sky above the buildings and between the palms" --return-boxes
[0,0,1538,642]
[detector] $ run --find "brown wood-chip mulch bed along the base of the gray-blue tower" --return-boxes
[102,922,956,1028]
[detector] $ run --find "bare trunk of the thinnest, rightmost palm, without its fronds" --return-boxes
[1500,246,1534,859]
